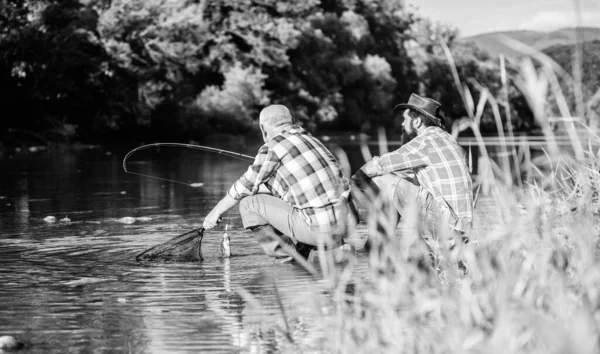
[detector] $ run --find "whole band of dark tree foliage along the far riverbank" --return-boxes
[0,0,540,145]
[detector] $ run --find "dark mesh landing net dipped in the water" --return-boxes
[135,227,204,262]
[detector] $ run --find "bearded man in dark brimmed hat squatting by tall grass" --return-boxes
[352,94,473,239]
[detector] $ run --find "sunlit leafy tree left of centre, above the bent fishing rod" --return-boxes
[99,0,316,136]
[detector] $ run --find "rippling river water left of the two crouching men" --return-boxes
[0,148,366,353]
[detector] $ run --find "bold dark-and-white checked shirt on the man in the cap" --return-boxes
[227,125,349,231]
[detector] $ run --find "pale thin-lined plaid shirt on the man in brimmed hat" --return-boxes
[374,127,473,231]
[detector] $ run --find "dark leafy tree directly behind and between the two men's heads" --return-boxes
[267,1,414,131]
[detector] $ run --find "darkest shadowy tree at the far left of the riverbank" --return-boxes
[0,0,137,139]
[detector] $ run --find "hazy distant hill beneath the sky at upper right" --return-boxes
[465,27,600,57]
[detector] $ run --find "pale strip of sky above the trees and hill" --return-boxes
[405,0,600,37]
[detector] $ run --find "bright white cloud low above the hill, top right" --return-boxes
[519,11,600,31]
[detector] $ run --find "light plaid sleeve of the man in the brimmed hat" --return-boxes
[374,137,429,175]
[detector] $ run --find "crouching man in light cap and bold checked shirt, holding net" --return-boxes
[203,105,356,260]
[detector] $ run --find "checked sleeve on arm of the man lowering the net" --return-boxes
[227,144,281,200]
